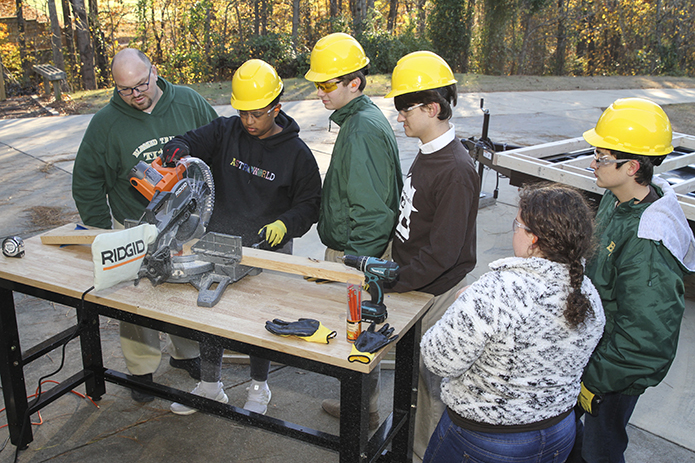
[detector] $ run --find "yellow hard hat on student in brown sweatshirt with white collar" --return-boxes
[386,51,456,98]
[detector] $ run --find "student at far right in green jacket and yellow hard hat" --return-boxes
[568,98,695,463]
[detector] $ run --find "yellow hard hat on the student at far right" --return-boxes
[584,98,673,156]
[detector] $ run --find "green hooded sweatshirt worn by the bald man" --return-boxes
[72,77,217,228]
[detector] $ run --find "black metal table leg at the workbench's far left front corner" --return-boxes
[0,288,34,448]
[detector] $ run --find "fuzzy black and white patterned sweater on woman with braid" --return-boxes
[420,257,605,425]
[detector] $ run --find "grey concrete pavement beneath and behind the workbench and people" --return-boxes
[0,89,695,463]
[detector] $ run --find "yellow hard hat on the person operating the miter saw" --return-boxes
[232,59,282,111]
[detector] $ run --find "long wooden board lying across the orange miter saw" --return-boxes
[41,224,364,283]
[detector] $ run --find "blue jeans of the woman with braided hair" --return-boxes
[422,412,575,463]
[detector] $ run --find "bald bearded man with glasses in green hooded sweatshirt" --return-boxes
[72,48,217,402]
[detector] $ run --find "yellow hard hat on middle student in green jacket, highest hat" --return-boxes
[304,32,369,82]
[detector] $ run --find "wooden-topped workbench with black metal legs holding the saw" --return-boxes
[0,229,432,461]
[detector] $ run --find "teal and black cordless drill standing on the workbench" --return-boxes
[342,254,398,323]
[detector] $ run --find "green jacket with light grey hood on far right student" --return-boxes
[583,177,694,395]
